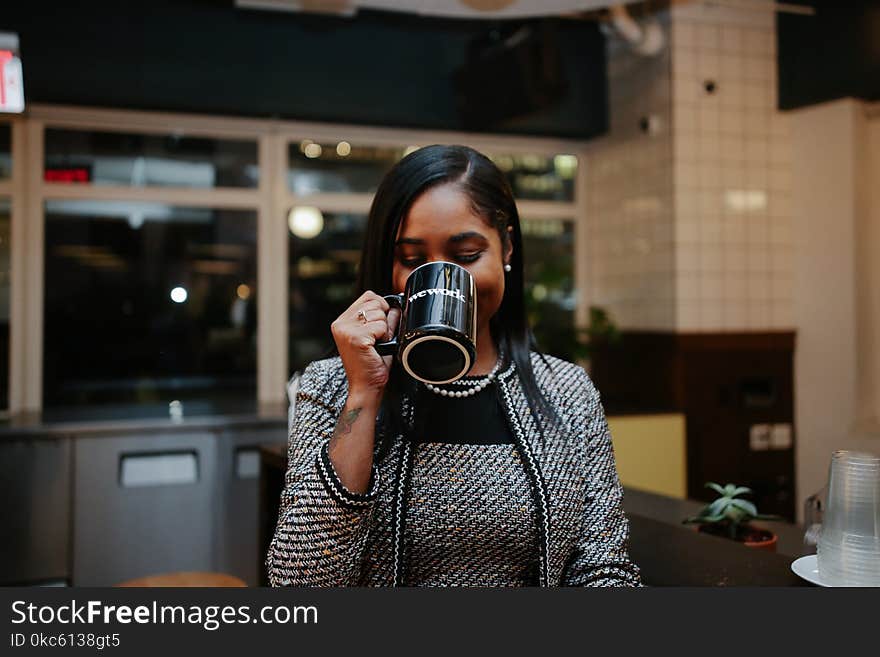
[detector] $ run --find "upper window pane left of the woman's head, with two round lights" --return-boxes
[287,139,408,196]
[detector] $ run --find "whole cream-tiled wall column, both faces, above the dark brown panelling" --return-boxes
[588,2,793,331]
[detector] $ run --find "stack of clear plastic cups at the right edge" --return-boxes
[818,451,880,586]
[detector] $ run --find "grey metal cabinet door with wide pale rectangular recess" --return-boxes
[73,431,218,586]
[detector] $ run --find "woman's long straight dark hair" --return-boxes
[356,144,556,455]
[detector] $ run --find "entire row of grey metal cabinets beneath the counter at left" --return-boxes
[0,419,286,586]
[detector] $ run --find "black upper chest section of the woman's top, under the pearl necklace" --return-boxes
[411,376,513,445]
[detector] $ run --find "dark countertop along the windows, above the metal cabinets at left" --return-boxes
[0,402,287,441]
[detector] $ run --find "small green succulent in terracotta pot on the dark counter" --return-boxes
[684,481,781,551]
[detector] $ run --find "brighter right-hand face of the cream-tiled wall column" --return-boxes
[671,2,793,331]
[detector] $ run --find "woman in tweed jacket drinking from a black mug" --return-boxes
[267,146,640,586]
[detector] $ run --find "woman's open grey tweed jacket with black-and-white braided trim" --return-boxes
[266,353,641,586]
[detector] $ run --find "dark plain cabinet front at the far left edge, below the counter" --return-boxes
[0,436,71,585]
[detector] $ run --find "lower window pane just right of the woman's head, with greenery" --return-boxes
[522,219,580,361]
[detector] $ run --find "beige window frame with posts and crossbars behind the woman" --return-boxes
[6,104,589,415]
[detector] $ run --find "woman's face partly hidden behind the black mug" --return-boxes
[392,183,513,329]
